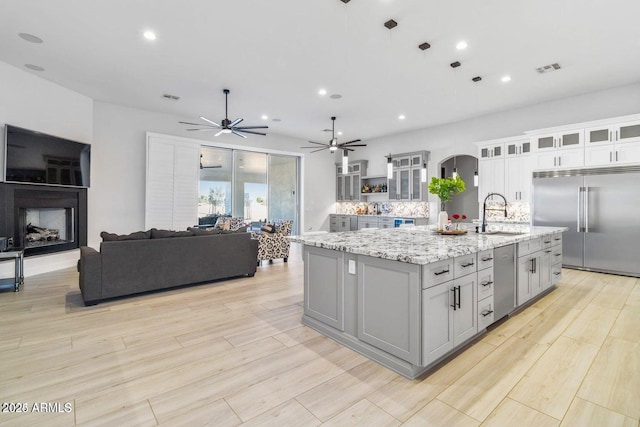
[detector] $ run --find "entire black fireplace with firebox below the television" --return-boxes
[0,183,87,256]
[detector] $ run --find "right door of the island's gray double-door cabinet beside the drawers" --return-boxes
[453,273,478,347]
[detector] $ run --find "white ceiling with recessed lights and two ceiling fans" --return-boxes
[0,0,640,142]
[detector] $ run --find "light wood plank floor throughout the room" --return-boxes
[0,247,640,427]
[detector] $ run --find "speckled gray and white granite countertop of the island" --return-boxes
[290,226,568,265]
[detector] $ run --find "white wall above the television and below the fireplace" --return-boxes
[0,62,93,277]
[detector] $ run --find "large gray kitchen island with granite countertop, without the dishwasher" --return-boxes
[291,226,566,379]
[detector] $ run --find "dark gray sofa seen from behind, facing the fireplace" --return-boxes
[78,229,258,305]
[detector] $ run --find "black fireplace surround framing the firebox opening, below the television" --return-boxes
[0,183,87,256]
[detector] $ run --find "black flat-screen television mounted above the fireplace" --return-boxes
[3,124,91,187]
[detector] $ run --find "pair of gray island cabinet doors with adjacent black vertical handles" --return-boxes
[422,272,478,366]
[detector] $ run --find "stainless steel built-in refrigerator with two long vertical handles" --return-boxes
[532,166,640,277]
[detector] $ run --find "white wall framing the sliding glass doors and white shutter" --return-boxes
[89,102,335,248]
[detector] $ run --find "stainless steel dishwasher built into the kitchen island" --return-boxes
[493,244,516,320]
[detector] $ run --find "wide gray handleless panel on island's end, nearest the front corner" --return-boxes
[357,256,421,365]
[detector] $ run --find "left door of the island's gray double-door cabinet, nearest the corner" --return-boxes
[422,282,453,366]
